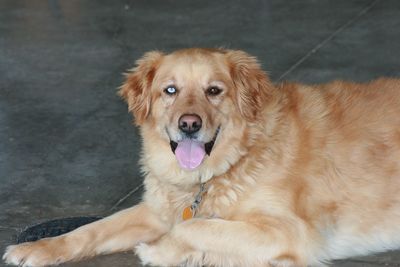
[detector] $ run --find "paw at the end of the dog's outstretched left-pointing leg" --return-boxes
[3,240,65,267]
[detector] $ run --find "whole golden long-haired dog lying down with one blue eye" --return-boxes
[4,48,400,267]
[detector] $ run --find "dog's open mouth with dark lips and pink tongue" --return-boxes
[169,127,221,170]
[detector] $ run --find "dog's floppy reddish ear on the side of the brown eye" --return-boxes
[226,50,273,122]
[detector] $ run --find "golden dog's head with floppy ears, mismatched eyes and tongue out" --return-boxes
[120,49,271,184]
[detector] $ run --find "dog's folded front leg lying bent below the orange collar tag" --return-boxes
[136,219,311,266]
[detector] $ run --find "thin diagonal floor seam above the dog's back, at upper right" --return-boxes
[278,0,381,81]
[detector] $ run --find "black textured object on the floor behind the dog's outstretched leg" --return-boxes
[17,216,102,243]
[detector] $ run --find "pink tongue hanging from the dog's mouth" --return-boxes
[175,139,206,170]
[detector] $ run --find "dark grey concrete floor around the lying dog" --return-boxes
[0,0,400,267]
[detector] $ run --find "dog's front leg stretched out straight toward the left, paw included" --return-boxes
[3,204,168,266]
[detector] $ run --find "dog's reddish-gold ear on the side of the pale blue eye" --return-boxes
[118,51,163,125]
